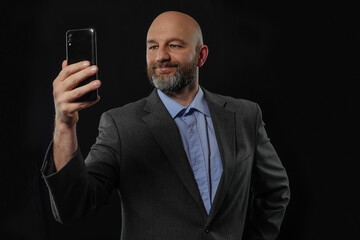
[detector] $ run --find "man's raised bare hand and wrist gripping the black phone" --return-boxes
[53,60,101,170]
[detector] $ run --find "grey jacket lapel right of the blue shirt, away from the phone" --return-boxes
[203,89,236,222]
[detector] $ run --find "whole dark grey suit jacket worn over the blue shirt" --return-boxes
[42,90,290,240]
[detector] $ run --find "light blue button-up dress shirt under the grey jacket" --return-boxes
[157,88,223,214]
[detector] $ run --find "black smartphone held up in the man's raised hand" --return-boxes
[66,28,98,102]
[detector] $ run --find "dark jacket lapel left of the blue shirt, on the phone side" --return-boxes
[143,90,205,212]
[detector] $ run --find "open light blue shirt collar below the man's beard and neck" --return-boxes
[157,87,210,118]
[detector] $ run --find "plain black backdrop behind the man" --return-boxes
[0,0,360,240]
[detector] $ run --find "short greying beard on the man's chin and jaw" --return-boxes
[150,66,196,92]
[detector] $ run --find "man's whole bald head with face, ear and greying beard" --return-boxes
[146,11,208,95]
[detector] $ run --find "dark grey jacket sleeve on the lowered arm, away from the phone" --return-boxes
[244,105,290,240]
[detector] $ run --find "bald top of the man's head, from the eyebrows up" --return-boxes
[147,11,203,48]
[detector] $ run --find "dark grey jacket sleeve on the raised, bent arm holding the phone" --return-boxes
[41,113,120,223]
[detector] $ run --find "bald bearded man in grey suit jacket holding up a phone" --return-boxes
[42,12,289,240]
